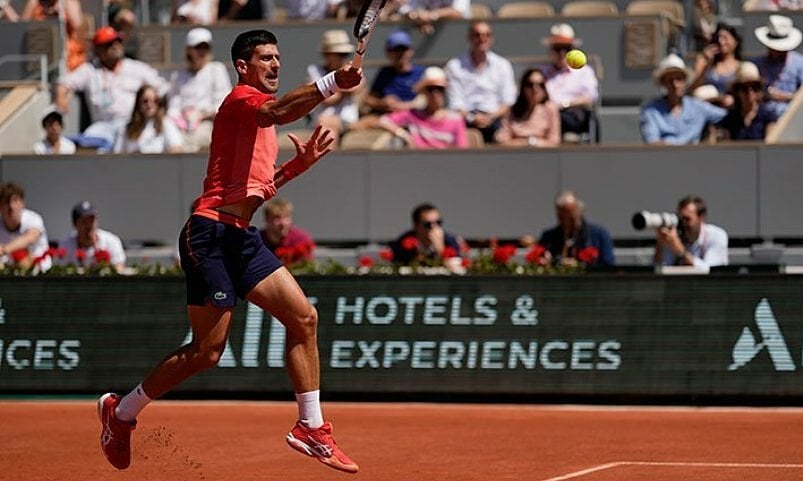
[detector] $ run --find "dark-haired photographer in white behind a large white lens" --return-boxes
[655,195,728,268]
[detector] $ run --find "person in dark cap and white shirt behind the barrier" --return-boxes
[59,201,126,272]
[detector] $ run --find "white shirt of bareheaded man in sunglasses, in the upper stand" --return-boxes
[446,52,517,113]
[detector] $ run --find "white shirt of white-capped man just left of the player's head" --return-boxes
[167,62,231,128]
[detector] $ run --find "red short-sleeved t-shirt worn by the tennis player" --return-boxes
[195,84,279,212]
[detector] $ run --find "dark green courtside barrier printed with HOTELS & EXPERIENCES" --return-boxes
[0,274,803,404]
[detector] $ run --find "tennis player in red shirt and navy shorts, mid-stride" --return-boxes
[98,30,363,473]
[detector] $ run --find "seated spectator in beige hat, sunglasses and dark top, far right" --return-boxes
[721,62,778,140]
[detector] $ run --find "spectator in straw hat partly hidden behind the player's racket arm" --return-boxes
[307,30,362,139]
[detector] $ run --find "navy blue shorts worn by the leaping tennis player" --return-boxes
[178,215,282,308]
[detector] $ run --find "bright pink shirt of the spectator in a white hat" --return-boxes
[385,110,468,149]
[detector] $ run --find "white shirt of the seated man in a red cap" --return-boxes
[59,58,169,123]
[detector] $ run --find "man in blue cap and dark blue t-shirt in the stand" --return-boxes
[355,30,424,128]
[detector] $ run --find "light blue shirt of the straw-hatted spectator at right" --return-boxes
[640,96,727,145]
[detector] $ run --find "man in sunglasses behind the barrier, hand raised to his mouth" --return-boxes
[390,203,463,271]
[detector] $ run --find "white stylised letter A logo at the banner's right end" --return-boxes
[728,298,795,371]
